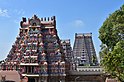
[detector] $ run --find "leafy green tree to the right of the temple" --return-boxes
[99,5,124,82]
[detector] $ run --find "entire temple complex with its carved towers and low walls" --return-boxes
[0,15,109,82]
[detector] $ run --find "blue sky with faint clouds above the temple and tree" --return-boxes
[0,0,124,60]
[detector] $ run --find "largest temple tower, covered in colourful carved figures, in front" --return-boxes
[2,15,66,82]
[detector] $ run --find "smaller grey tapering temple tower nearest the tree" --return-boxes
[73,33,98,66]
